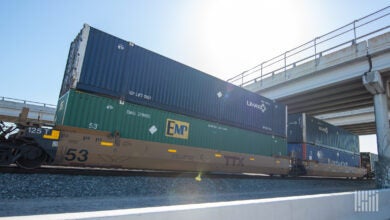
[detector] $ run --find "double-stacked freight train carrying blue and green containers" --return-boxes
[0,25,378,177]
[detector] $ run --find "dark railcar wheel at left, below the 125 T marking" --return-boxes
[15,146,47,169]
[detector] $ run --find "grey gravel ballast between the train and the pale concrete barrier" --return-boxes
[0,173,375,216]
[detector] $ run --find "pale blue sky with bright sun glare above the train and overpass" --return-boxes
[0,0,390,152]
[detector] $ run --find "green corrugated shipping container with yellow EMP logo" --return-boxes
[55,90,287,156]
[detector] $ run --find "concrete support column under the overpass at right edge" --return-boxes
[363,71,390,188]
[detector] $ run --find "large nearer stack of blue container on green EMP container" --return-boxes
[56,25,287,156]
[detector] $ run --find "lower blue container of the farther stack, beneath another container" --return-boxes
[287,143,360,167]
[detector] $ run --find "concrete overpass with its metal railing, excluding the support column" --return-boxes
[228,6,390,135]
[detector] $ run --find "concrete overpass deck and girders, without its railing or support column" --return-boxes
[245,29,390,135]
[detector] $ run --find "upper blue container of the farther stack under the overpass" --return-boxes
[288,113,359,153]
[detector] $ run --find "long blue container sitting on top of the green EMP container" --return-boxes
[60,25,287,137]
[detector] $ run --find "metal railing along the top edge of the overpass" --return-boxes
[227,6,390,87]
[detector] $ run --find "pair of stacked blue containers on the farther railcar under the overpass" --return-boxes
[287,113,360,167]
